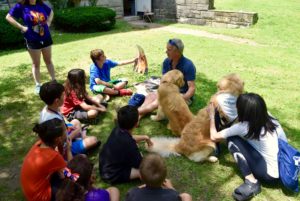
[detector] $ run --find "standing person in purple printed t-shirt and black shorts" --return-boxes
[6,0,55,94]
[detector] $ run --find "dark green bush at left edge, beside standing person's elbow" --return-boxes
[0,10,23,49]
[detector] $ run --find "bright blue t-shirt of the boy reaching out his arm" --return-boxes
[90,59,118,90]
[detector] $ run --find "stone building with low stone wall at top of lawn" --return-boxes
[89,0,258,28]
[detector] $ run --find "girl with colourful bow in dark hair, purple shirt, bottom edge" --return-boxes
[56,154,120,201]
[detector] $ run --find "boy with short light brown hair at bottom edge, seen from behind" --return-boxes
[125,154,192,201]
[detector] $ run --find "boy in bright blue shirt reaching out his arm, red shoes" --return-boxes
[90,49,136,96]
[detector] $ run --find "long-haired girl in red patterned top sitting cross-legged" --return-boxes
[61,69,106,121]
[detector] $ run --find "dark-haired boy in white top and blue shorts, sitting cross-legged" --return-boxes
[40,81,100,157]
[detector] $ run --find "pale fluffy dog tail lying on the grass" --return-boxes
[147,137,180,157]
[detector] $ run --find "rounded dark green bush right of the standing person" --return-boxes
[54,7,116,32]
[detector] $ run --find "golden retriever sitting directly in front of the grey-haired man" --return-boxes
[151,69,193,136]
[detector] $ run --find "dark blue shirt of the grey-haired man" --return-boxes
[162,56,196,93]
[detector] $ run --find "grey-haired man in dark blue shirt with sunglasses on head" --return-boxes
[139,38,196,117]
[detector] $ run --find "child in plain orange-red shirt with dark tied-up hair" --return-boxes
[21,119,71,201]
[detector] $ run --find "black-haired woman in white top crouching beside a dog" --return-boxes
[209,93,286,200]
